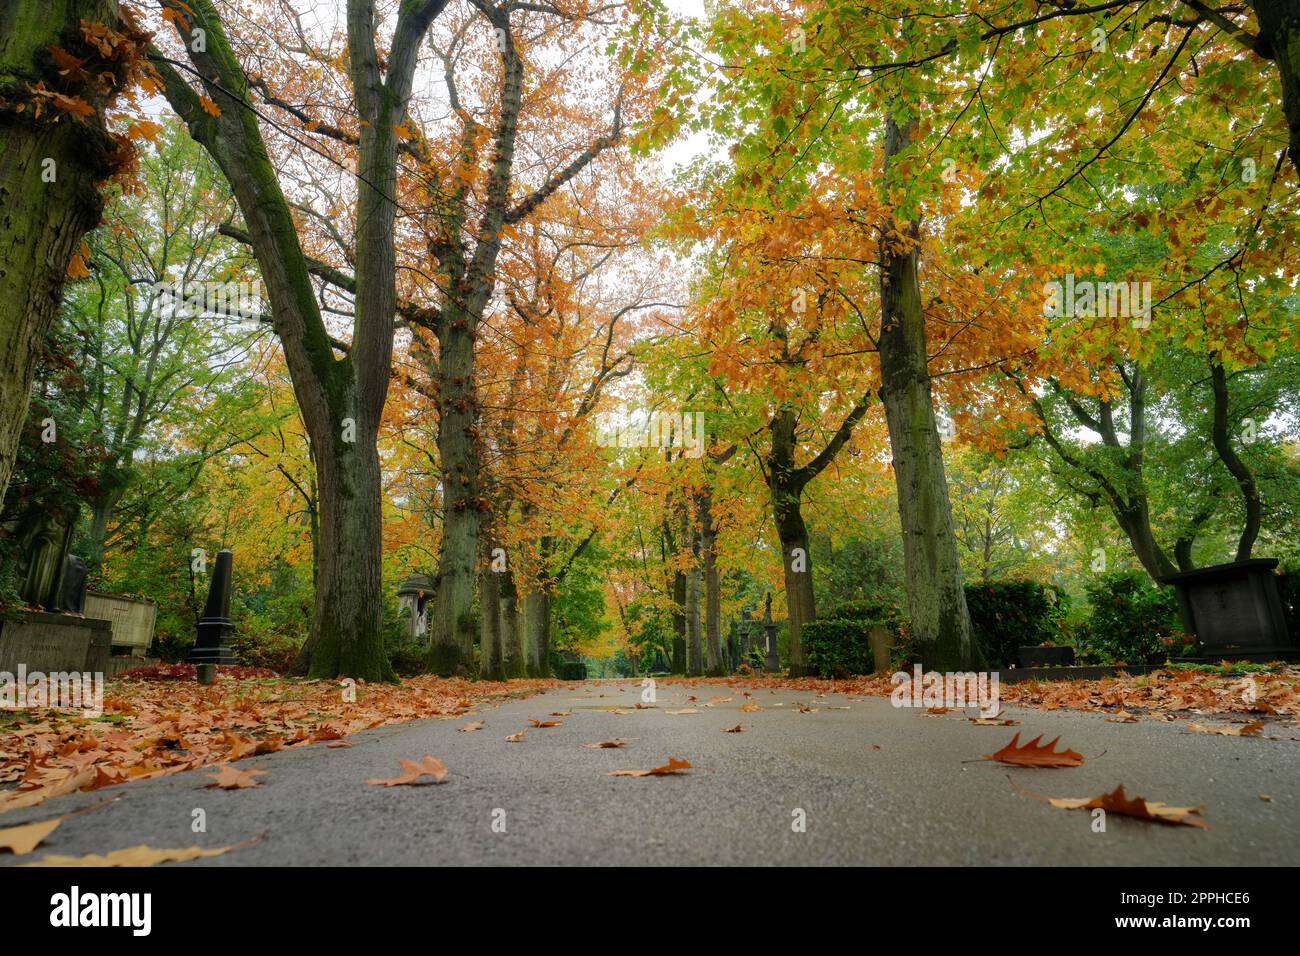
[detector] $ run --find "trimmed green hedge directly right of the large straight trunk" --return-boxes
[966,581,1069,669]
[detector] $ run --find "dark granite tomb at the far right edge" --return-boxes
[1161,558,1300,661]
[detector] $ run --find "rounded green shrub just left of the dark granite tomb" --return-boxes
[1076,571,1184,663]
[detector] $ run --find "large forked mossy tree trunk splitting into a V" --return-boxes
[153,0,446,680]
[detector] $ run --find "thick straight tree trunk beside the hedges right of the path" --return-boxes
[879,111,984,671]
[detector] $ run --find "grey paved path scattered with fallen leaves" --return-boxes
[0,682,1300,866]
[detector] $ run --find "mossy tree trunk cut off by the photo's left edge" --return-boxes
[0,0,121,499]
